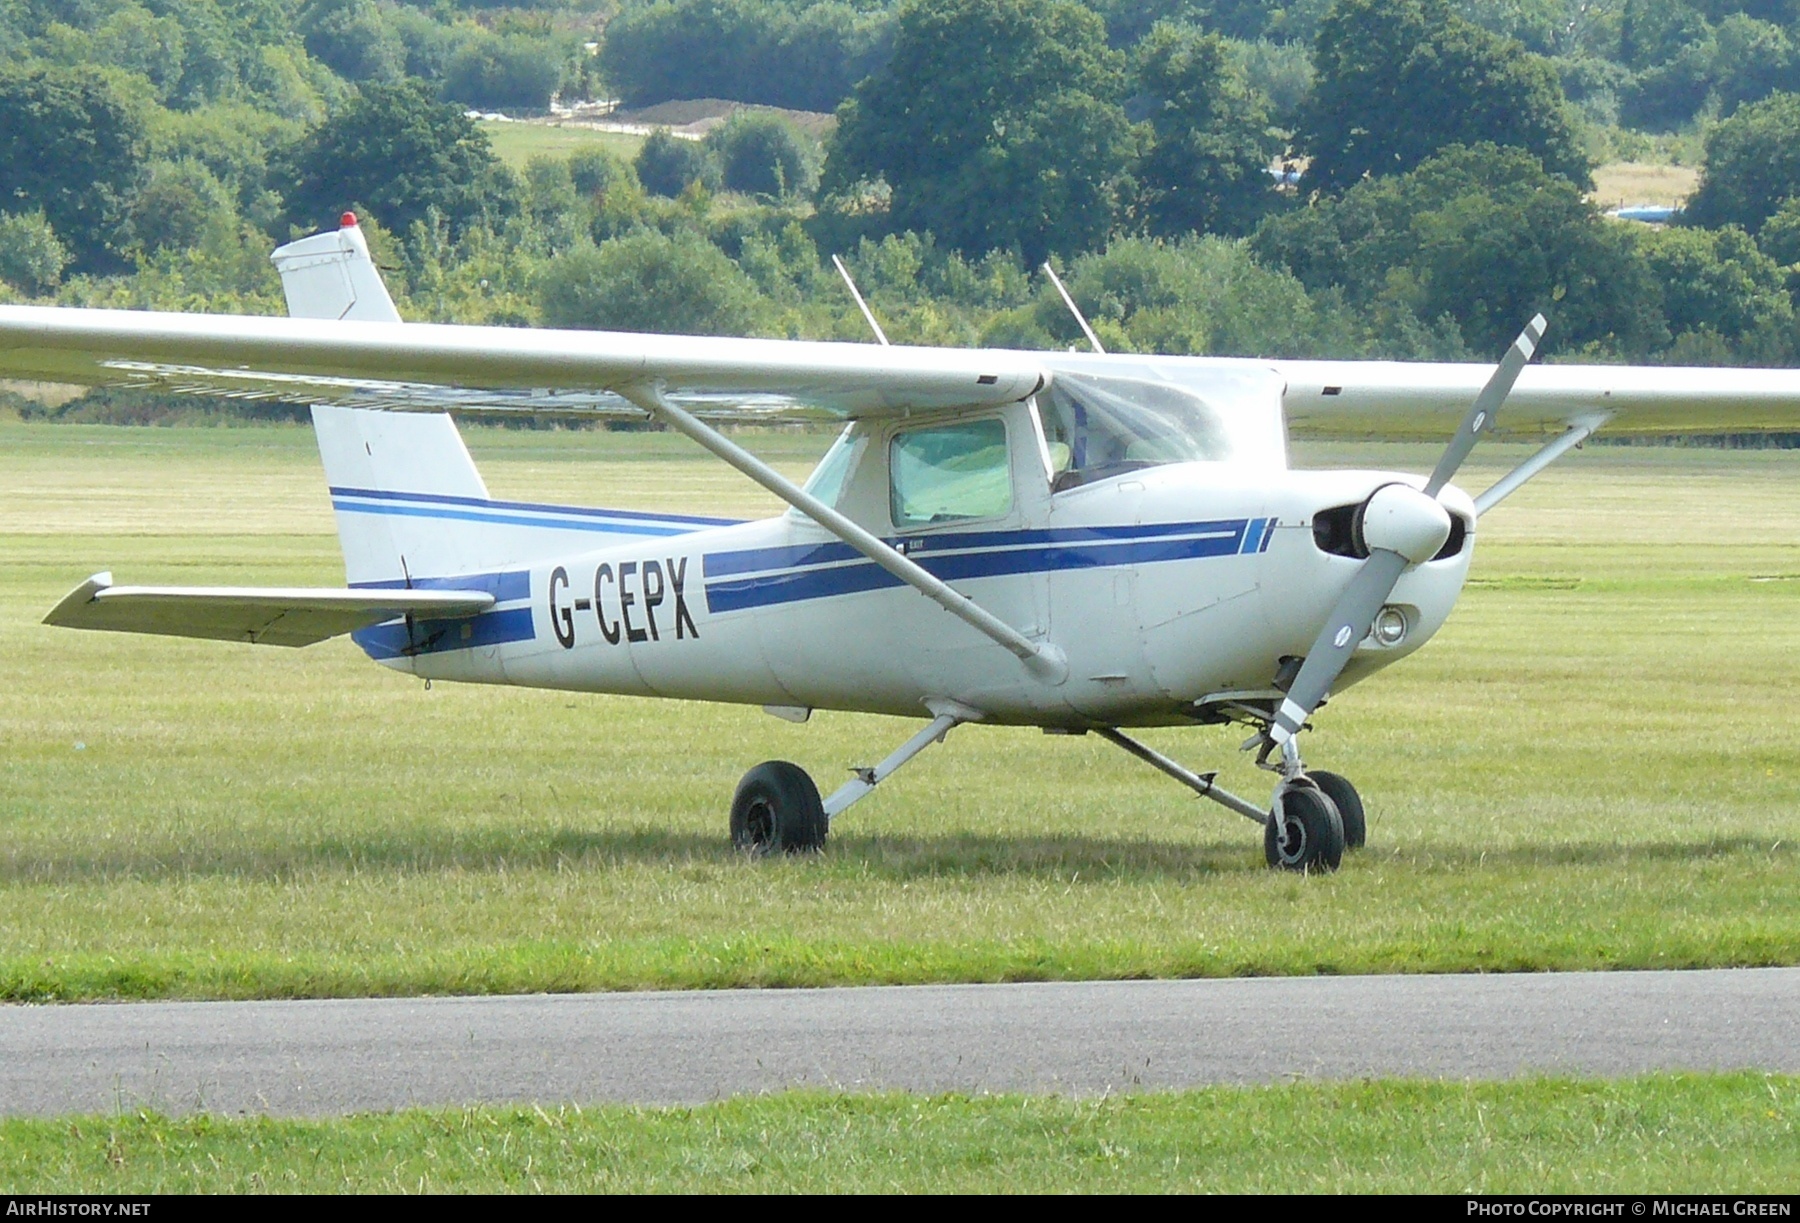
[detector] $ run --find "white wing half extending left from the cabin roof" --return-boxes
[0,306,1048,418]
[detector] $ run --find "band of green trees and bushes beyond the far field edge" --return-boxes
[0,0,1800,392]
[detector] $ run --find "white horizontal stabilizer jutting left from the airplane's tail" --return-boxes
[43,573,493,645]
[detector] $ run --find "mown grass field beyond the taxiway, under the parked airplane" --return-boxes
[0,423,1800,1000]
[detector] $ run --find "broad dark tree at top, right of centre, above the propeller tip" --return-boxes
[1294,0,1589,193]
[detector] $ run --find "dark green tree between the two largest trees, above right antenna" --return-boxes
[1138,25,1282,234]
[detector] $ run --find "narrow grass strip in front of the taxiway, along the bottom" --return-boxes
[0,1074,1800,1194]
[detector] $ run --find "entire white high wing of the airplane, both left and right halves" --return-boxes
[0,306,1800,438]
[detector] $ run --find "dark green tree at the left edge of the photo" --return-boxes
[0,65,149,270]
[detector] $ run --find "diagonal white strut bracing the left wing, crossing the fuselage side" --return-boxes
[619,384,1069,684]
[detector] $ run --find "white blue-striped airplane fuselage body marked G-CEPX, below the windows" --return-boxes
[369,463,1474,728]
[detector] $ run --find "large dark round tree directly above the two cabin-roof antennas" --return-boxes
[823,0,1136,263]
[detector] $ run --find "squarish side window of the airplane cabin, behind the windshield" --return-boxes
[887,418,1012,526]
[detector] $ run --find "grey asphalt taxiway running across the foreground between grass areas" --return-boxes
[0,969,1800,1117]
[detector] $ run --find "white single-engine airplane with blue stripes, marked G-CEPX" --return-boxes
[0,216,1800,870]
